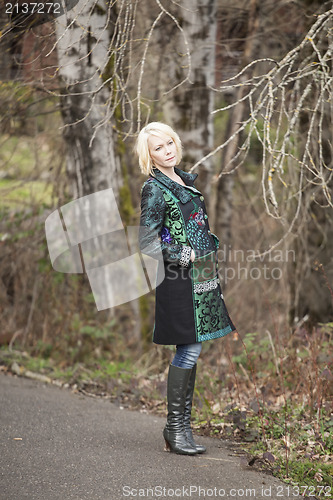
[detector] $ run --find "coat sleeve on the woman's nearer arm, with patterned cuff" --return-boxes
[139,182,192,267]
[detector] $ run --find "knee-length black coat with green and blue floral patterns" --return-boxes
[140,168,235,345]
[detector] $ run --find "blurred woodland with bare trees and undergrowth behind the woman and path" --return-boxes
[0,0,333,497]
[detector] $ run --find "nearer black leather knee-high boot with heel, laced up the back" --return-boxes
[163,365,198,455]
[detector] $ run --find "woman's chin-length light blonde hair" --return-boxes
[135,122,183,175]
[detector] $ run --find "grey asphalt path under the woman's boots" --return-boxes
[0,374,297,500]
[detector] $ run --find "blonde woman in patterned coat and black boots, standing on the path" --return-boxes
[136,122,235,455]
